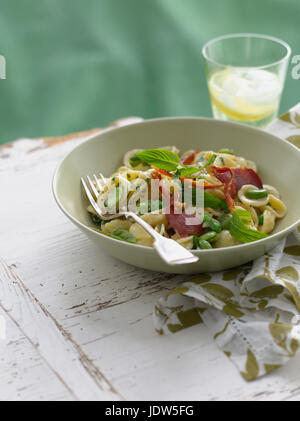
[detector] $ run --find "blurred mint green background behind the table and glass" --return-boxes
[0,0,300,143]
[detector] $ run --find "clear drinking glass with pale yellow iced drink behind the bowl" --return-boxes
[202,34,291,129]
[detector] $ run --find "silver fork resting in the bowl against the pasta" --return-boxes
[81,174,199,265]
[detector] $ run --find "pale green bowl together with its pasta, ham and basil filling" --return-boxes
[53,118,300,274]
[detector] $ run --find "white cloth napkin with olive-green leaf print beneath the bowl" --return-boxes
[154,103,300,381]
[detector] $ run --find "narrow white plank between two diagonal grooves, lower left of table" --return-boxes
[0,259,121,400]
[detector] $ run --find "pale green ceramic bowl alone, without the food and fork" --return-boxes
[53,118,300,274]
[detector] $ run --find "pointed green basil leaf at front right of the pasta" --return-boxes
[229,210,268,243]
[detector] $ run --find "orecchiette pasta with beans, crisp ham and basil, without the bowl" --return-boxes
[88,146,287,250]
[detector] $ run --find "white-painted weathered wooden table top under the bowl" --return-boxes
[0,115,300,400]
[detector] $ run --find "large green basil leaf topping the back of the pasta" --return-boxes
[135,149,180,171]
